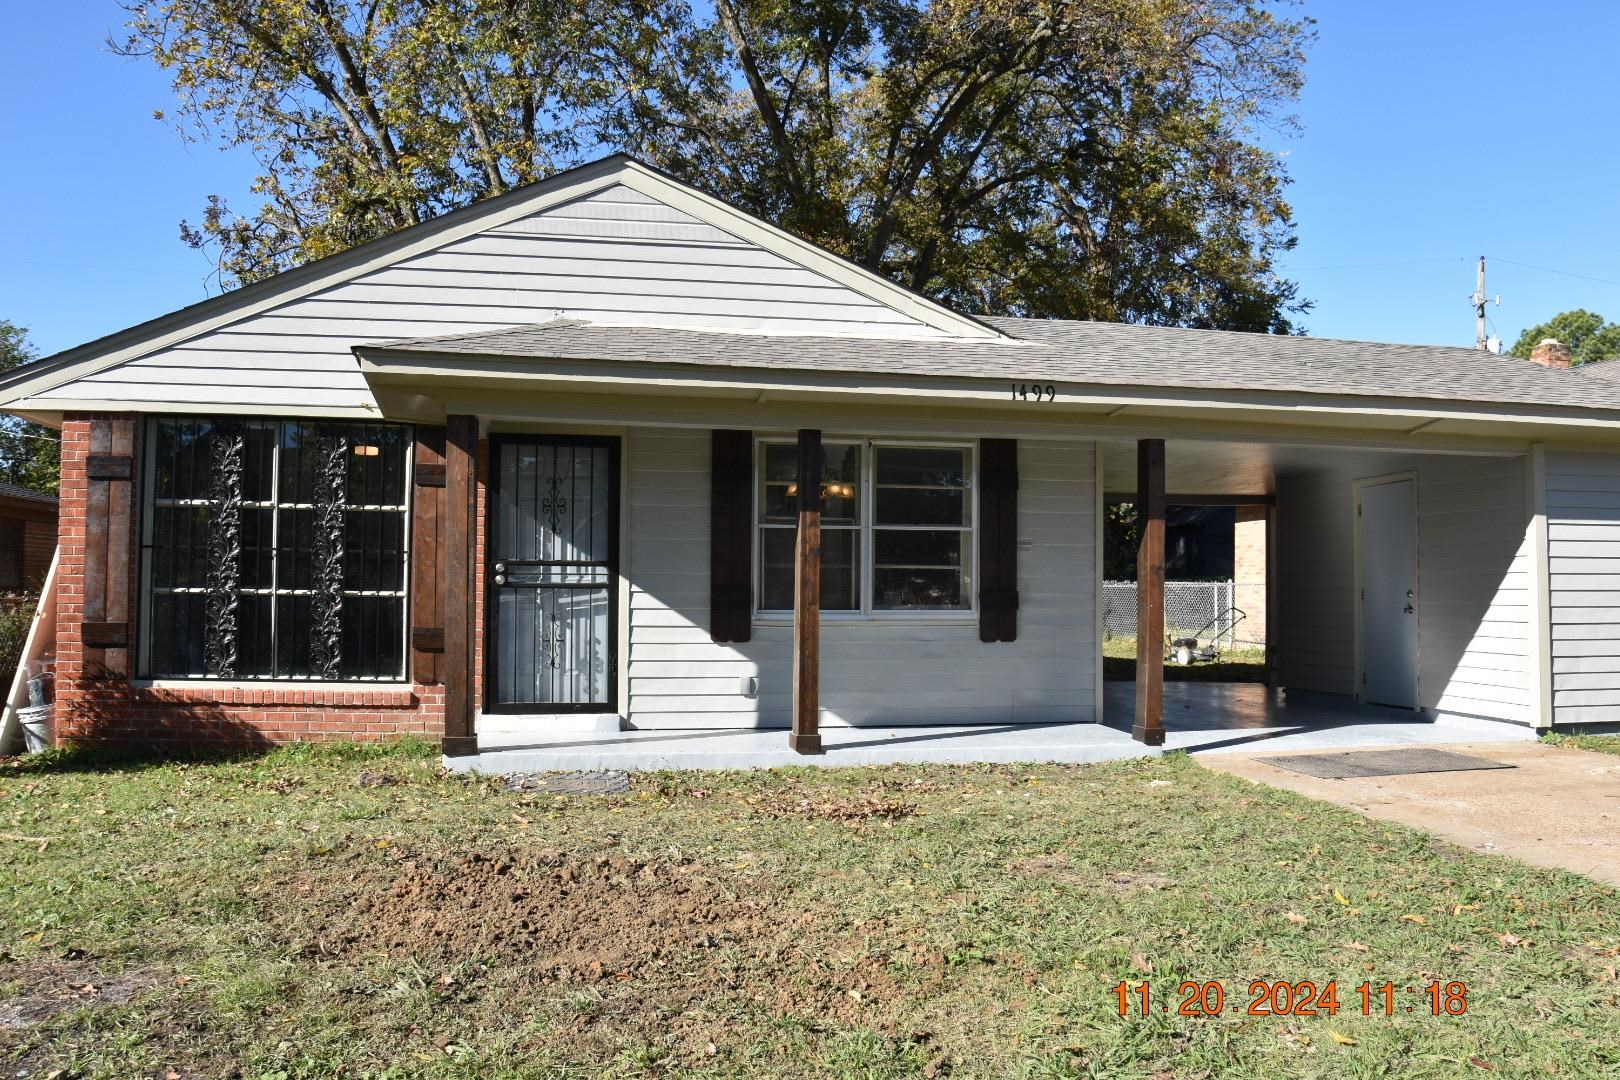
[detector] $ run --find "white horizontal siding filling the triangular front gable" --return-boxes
[41,186,940,411]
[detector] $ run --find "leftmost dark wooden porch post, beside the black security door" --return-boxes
[439,416,478,755]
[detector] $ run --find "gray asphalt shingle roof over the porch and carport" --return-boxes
[356,317,1620,410]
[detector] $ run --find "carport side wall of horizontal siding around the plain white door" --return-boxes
[1272,455,1529,722]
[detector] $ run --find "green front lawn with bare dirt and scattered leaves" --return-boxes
[0,745,1620,1080]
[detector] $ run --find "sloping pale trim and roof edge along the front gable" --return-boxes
[0,154,998,411]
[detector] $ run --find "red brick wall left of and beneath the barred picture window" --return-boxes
[55,415,444,745]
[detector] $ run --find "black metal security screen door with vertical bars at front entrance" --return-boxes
[488,436,619,712]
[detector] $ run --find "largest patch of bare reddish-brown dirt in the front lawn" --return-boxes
[272,850,920,1061]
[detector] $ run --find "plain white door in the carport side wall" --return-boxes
[1358,479,1418,709]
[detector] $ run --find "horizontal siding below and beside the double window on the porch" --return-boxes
[625,431,1098,727]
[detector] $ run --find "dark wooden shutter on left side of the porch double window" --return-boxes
[710,431,753,641]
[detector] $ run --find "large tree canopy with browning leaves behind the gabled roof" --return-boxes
[123,0,1312,332]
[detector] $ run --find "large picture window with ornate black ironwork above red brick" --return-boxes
[141,419,411,680]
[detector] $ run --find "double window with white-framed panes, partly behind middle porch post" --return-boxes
[755,440,977,614]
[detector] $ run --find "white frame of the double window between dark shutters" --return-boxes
[750,432,980,625]
